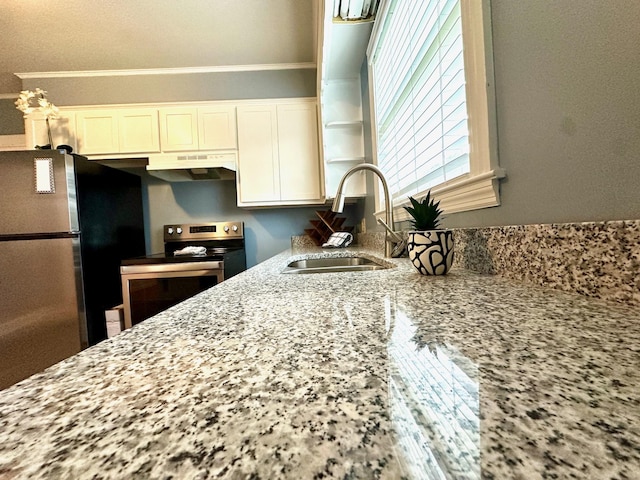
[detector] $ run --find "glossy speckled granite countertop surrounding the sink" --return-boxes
[0,247,640,479]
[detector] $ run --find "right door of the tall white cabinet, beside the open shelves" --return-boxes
[277,103,322,201]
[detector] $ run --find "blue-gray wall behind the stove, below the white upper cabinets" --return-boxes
[143,174,362,267]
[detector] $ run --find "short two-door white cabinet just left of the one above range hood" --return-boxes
[76,108,160,155]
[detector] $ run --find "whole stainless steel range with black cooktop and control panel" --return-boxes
[120,222,247,328]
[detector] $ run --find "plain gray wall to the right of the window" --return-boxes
[364,0,640,227]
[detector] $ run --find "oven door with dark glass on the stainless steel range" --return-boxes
[120,261,224,328]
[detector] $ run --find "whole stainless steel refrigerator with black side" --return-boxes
[0,150,145,389]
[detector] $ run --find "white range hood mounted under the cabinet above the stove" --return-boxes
[147,151,237,182]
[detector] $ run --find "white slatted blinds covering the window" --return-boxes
[370,0,469,201]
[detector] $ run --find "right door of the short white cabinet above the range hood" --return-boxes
[198,106,238,150]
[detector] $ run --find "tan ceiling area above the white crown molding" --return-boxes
[0,0,318,76]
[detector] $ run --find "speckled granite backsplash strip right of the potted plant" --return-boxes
[455,220,640,306]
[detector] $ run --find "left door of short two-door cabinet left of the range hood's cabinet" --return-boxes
[76,110,120,155]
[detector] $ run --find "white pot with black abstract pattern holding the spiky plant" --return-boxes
[407,230,453,275]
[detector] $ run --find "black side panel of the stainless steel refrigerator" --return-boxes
[74,156,145,345]
